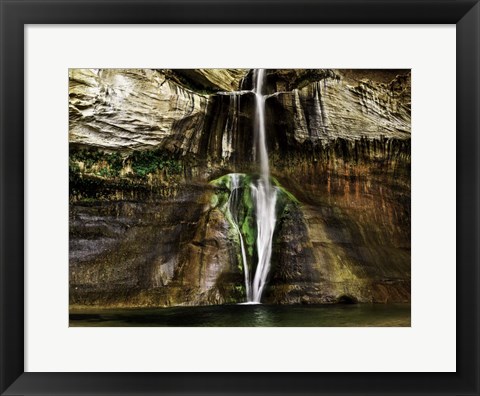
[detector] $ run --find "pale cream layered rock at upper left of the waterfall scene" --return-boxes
[69,69,207,150]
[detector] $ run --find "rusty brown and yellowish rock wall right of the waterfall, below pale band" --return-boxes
[266,139,411,303]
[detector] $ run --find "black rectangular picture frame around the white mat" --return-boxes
[0,0,480,396]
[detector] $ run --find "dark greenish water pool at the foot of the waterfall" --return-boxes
[70,304,410,327]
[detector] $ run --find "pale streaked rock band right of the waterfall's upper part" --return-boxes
[267,70,410,152]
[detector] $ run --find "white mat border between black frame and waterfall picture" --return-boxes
[25,25,455,371]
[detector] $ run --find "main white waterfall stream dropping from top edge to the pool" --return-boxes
[250,69,277,303]
